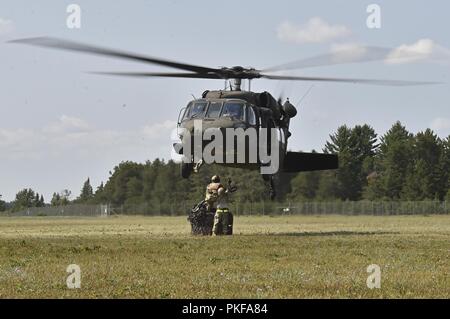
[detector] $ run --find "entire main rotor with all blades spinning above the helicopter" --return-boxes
[10,37,437,86]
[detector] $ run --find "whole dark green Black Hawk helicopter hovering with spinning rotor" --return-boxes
[11,37,435,198]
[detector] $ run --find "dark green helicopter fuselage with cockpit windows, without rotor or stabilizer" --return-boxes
[178,92,288,177]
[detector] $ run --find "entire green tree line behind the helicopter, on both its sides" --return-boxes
[0,122,450,210]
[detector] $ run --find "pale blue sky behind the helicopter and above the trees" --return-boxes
[0,0,450,200]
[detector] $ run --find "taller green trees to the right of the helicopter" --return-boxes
[287,122,450,201]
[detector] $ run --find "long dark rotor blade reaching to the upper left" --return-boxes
[10,37,220,73]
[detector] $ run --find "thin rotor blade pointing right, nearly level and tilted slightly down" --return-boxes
[261,74,440,86]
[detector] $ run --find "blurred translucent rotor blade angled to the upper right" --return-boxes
[263,45,424,72]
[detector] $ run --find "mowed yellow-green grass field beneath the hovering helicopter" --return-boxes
[0,216,450,298]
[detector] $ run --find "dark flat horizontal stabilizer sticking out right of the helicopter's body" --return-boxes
[283,152,339,173]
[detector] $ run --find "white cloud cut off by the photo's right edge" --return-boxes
[385,39,450,64]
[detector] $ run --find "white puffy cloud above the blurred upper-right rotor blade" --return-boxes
[277,17,351,43]
